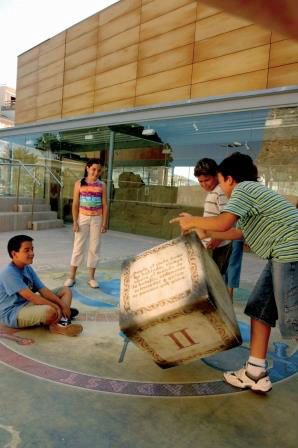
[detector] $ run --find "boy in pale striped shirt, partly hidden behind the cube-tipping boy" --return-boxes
[194,158,232,275]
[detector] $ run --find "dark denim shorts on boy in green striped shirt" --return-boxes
[244,260,298,338]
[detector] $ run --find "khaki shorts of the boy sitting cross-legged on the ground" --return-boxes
[17,288,63,328]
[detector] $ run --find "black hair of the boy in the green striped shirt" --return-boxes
[218,152,258,183]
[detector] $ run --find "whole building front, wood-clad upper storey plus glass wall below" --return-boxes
[0,0,298,238]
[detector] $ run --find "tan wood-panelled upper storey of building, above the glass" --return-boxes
[16,0,298,124]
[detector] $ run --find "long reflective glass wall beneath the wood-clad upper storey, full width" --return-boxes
[0,107,298,238]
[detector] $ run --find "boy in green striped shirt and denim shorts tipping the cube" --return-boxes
[171,153,298,393]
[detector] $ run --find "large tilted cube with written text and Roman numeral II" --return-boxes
[120,232,242,368]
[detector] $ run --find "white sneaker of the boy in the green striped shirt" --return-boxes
[224,363,272,393]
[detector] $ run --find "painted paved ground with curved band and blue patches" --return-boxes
[0,227,298,448]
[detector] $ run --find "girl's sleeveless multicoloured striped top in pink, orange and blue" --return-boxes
[80,180,104,216]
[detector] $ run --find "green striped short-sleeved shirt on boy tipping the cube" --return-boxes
[223,181,298,263]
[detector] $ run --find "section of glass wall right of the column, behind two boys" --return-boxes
[111,108,298,238]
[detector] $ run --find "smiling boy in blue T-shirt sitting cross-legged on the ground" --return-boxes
[0,235,83,336]
